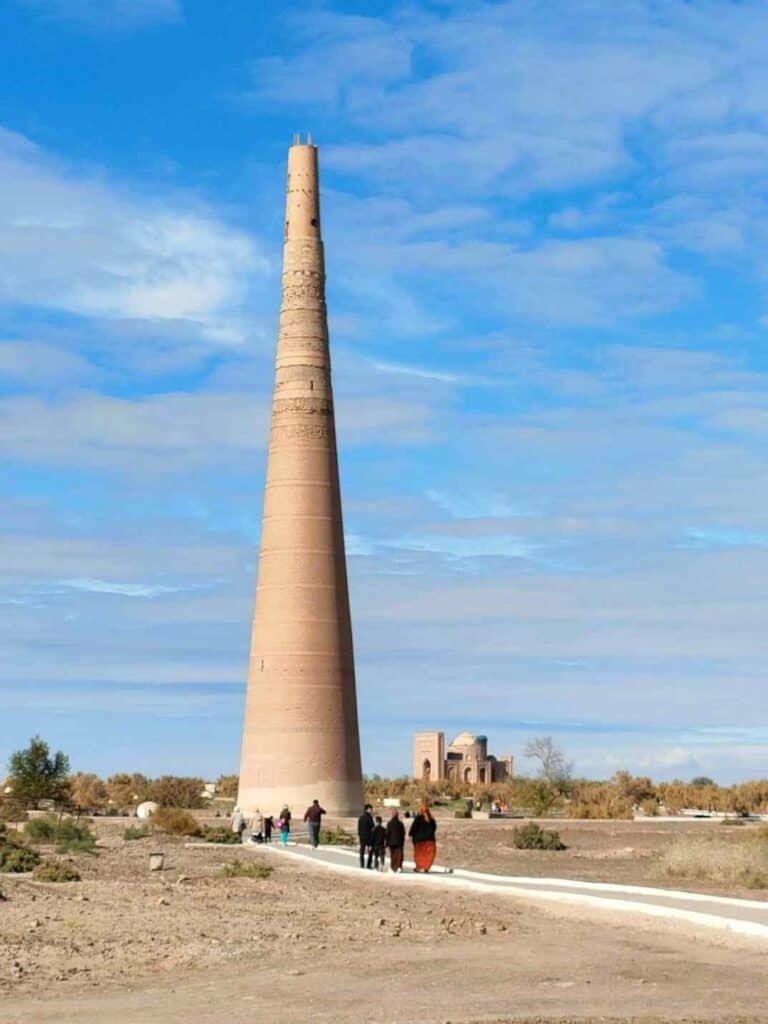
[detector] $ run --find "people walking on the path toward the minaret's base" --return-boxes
[231,800,437,871]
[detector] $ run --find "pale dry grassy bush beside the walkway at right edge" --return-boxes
[658,837,768,889]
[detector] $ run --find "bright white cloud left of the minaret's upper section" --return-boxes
[0,129,268,343]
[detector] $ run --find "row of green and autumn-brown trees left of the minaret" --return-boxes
[0,736,238,814]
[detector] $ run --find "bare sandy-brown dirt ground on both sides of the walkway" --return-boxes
[0,819,768,1024]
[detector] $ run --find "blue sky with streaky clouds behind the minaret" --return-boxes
[0,0,768,781]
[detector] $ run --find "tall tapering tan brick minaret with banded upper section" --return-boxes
[238,136,362,815]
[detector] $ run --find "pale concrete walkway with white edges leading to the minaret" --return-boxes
[249,843,768,942]
